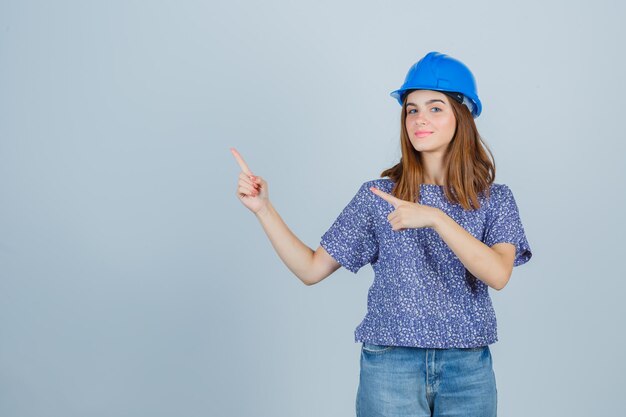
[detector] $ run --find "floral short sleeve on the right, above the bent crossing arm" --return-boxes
[483,184,532,266]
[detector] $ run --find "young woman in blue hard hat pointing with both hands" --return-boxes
[232,52,532,417]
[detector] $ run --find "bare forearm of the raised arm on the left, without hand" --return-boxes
[251,202,314,285]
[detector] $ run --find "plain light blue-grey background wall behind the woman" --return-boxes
[0,0,626,417]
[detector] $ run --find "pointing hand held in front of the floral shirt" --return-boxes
[370,187,441,230]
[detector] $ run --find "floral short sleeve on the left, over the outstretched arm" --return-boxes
[320,183,378,274]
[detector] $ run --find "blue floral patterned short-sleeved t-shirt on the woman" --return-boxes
[320,178,532,348]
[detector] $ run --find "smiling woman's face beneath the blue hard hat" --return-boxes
[405,90,456,152]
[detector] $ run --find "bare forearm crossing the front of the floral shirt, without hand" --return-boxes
[433,209,506,290]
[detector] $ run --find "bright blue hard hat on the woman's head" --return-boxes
[391,51,482,118]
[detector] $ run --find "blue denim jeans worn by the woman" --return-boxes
[356,343,498,417]
